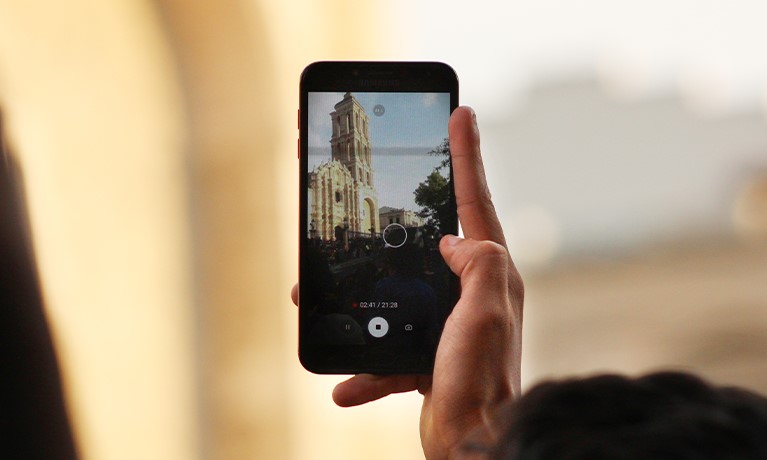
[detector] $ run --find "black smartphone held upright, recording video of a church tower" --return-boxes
[298,62,458,374]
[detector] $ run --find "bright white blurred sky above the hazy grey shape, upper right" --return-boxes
[392,0,767,117]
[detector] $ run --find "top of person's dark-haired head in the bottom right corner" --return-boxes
[469,372,767,460]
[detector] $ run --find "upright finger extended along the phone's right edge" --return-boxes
[448,107,506,246]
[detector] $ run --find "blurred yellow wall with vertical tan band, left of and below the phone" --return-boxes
[0,0,420,459]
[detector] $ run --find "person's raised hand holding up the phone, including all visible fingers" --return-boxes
[292,107,524,459]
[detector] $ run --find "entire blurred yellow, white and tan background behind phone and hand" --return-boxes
[0,0,767,460]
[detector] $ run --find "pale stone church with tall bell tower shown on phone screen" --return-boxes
[309,93,381,241]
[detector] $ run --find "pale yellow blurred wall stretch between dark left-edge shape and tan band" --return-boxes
[0,0,197,458]
